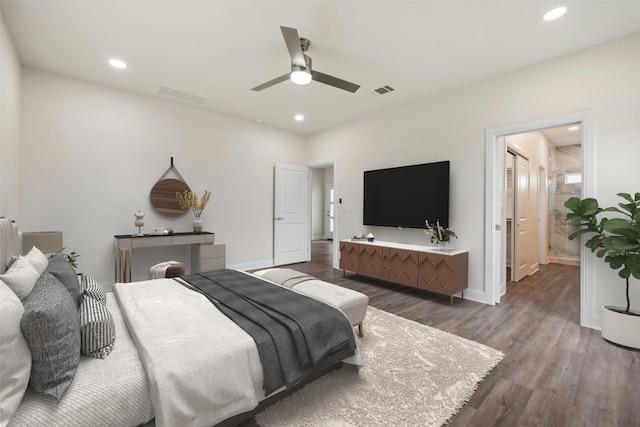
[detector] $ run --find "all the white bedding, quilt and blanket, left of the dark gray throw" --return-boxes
[8,270,361,427]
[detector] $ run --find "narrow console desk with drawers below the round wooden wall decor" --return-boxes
[113,232,225,283]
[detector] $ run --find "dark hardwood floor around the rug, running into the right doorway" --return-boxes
[243,241,640,427]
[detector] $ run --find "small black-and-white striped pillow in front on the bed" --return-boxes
[79,297,116,359]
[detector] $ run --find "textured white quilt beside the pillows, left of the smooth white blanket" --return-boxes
[8,293,153,427]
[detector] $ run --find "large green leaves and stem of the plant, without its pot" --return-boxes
[564,193,640,315]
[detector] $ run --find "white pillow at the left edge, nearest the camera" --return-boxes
[0,281,31,426]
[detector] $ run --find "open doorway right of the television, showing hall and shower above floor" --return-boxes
[504,123,582,283]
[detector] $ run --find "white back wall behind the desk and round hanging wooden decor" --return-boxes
[18,68,306,282]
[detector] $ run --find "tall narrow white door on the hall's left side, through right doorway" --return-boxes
[512,156,530,282]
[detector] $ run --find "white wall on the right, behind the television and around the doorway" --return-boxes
[309,34,640,312]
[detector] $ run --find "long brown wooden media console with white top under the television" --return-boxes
[340,240,469,305]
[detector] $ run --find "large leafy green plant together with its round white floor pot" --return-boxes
[564,193,640,348]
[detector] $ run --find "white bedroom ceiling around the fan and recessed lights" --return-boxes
[0,0,640,134]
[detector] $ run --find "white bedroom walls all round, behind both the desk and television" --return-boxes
[5,22,640,320]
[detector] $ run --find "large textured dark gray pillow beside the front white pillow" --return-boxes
[20,271,80,400]
